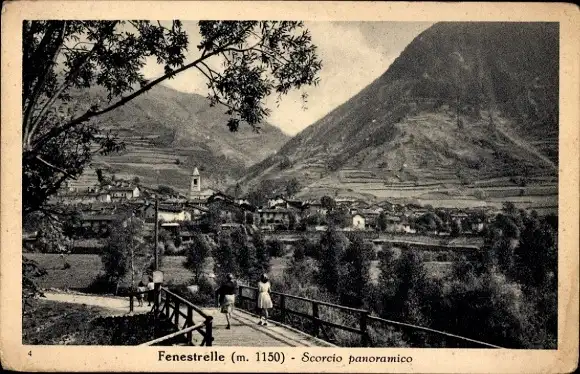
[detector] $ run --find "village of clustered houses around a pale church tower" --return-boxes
[24,168,495,261]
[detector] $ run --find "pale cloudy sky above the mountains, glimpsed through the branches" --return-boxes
[143,21,431,135]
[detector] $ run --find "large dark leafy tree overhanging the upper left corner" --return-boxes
[22,20,321,214]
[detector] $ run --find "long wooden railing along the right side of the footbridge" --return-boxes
[236,286,502,348]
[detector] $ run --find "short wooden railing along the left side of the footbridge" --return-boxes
[129,287,213,347]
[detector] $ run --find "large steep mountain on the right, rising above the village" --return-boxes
[240,22,559,210]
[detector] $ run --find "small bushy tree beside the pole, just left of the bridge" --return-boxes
[101,217,154,294]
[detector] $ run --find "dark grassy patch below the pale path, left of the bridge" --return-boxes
[22,299,175,345]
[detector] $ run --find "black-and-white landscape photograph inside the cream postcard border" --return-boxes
[3,4,577,370]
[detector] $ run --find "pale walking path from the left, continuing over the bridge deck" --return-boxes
[44,292,332,347]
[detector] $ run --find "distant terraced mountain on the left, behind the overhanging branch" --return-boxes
[67,85,288,192]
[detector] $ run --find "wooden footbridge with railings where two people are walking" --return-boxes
[129,285,501,348]
